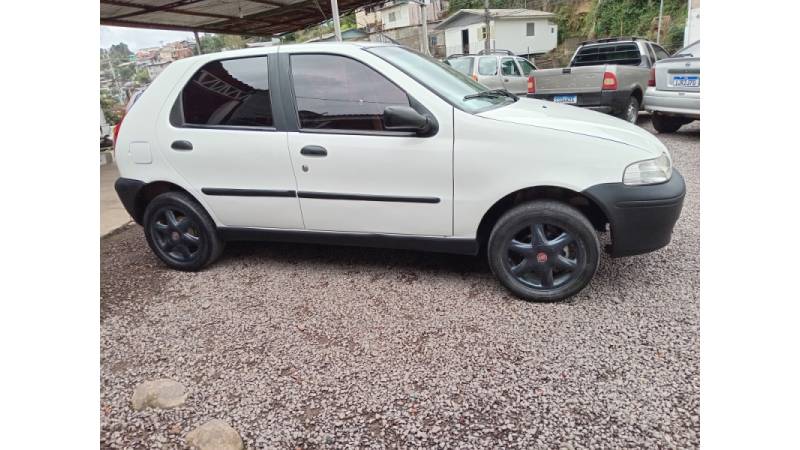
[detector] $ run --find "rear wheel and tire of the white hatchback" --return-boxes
[143,192,225,271]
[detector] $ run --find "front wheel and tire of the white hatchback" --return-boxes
[487,200,600,302]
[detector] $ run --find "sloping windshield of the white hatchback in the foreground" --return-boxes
[368,46,516,113]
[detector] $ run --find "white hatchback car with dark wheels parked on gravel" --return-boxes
[116,43,685,300]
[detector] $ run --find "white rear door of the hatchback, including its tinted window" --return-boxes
[158,56,303,229]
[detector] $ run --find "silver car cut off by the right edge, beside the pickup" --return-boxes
[644,41,700,133]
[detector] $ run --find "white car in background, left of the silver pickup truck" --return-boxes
[445,50,536,95]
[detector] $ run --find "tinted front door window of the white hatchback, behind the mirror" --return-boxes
[291,55,409,131]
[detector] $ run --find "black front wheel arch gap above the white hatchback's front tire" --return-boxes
[476,185,609,246]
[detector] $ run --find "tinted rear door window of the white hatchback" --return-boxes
[182,56,273,127]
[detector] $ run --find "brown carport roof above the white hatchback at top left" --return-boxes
[100,0,376,36]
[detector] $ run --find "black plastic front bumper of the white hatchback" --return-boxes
[583,169,686,257]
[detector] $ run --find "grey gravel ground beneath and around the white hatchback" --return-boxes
[100,118,700,448]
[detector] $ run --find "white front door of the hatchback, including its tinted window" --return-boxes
[288,52,453,236]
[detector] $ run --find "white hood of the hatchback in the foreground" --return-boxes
[478,98,667,157]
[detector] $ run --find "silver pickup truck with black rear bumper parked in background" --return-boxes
[528,37,669,123]
